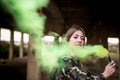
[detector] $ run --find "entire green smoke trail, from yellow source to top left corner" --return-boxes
[1,0,108,71]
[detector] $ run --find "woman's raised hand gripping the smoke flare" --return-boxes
[102,61,116,78]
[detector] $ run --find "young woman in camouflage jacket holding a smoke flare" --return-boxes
[52,25,116,80]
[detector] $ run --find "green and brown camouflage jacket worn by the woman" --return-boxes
[51,56,105,80]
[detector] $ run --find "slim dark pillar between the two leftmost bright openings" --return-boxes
[8,30,14,59]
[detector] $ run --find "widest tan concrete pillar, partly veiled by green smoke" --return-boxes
[27,36,41,80]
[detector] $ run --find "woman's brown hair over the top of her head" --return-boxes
[65,24,86,41]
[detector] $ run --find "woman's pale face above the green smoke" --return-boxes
[69,30,85,46]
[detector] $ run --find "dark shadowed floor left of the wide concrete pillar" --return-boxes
[0,58,27,80]
